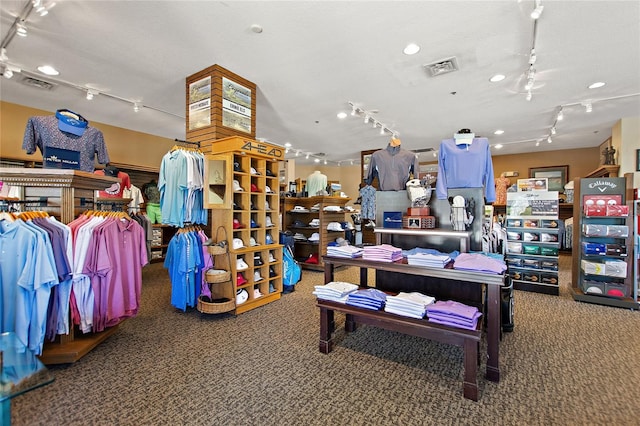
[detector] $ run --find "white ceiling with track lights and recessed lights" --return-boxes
[0,0,640,164]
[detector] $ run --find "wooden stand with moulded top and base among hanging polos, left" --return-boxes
[0,168,125,364]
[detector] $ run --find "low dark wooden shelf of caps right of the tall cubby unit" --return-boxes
[282,195,351,271]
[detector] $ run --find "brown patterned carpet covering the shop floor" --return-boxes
[12,255,640,426]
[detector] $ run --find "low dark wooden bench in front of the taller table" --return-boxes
[317,299,482,401]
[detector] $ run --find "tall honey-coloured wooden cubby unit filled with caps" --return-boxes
[206,137,282,314]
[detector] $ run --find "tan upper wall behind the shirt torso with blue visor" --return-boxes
[0,102,175,171]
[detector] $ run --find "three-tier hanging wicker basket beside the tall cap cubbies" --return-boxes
[197,226,236,314]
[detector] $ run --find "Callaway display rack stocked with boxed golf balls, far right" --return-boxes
[571,173,640,309]
